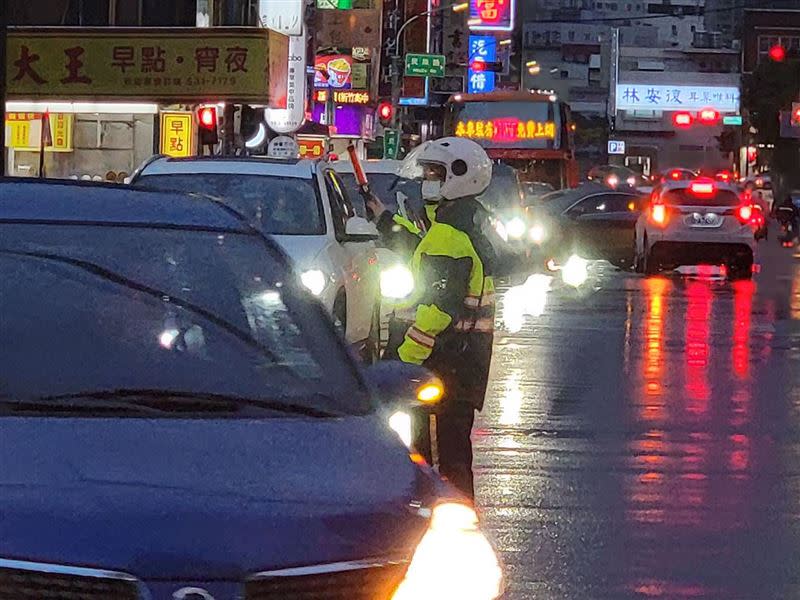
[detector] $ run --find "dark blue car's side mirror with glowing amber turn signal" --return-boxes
[364,360,444,409]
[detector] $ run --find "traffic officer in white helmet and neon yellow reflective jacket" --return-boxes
[387,138,496,497]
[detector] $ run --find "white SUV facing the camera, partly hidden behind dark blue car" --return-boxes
[131,157,380,359]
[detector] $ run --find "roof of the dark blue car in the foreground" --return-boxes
[0,177,251,233]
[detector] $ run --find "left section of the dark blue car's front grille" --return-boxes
[0,565,139,600]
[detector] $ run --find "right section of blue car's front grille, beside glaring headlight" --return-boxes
[245,562,408,600]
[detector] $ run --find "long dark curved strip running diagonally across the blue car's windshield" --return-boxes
[0,248,282,364]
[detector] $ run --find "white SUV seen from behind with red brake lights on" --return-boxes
[635,178,756,279]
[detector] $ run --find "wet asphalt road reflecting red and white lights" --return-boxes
[473,240,800,600]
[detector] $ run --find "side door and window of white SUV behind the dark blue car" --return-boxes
[324,169,379,341]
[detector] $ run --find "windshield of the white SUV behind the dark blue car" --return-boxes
[134,173,325,235]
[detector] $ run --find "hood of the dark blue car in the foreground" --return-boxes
[0,415,437,580]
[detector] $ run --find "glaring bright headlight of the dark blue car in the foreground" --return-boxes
[392,502,503,600]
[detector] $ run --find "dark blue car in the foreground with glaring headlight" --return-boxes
[0,180,501,600]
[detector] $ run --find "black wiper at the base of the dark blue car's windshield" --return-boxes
[32,388,343,418]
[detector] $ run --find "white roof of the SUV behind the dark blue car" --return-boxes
[137,156,319,179]
